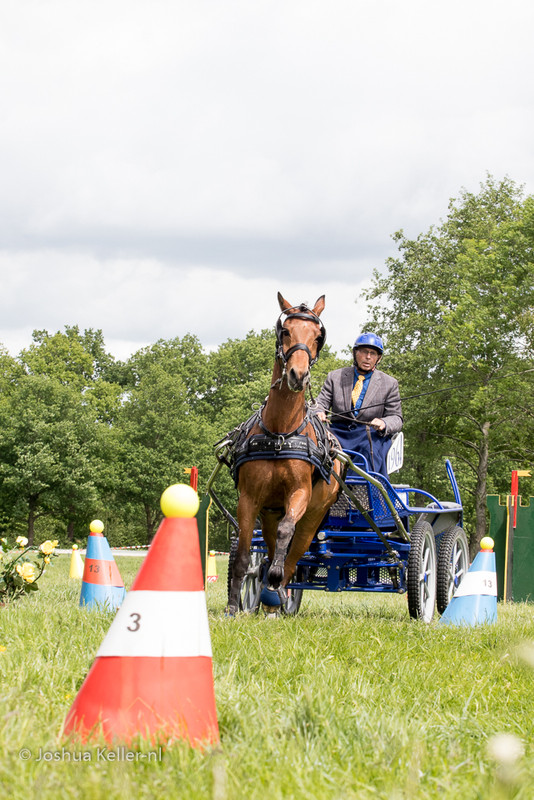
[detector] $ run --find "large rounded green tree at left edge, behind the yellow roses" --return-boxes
[0,326,123,540]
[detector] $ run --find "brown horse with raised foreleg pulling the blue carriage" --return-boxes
[227,292,341,616]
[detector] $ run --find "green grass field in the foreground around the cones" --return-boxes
[0,556,534,800]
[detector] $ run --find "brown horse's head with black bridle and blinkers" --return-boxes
[276,292,326,392]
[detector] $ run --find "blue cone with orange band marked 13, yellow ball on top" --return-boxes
[80,519,126,611]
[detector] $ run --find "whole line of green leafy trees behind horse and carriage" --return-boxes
[0,177,534,551]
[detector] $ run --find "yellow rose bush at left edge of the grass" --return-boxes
[0,536,58,603]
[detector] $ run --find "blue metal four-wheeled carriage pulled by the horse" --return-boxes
[208,434,469,623]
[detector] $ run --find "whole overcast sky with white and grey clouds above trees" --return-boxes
[0,0,534,358]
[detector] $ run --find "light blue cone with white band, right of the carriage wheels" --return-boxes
[440,536,497,626]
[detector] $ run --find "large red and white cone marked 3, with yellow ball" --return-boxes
[64,484,219,745]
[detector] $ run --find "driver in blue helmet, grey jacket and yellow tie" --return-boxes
[317,333,403,475]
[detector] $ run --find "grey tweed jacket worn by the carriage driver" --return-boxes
[317,367,403,436]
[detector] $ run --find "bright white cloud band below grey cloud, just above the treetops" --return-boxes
[0,253,372,358]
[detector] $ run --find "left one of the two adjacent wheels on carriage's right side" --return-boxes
[408,521,437,622]
